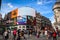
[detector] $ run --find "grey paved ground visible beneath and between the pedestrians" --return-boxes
[0,35,60,40]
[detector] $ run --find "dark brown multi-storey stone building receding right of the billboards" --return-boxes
[36,13,52,30]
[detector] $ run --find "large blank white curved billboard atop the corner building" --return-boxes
[18,7,36,17]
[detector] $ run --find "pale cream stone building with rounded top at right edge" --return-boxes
[53,0,60,29]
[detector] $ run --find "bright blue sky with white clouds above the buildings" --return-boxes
[0,0,56,23]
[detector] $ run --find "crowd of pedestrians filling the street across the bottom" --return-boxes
[0,28,60,40]
